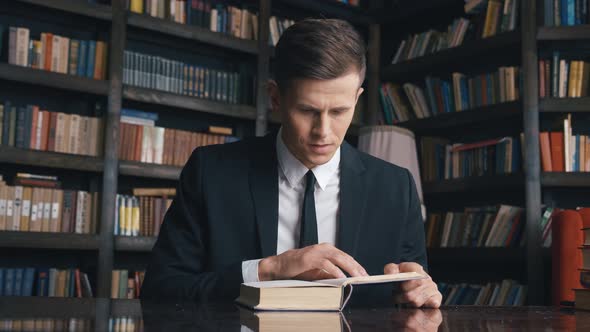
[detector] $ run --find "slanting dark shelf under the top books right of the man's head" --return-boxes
[381,31,521,80]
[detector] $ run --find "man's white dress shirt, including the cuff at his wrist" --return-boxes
[242,129,340,282]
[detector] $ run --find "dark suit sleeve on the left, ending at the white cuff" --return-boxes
[141,149,242,300]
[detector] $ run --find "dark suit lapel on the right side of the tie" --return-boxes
[337,142,367,257]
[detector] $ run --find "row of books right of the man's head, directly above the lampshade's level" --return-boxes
[379,67,520,124]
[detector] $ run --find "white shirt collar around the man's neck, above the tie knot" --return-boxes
[276,127,340,190]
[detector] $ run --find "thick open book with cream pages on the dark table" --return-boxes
[236,272,427,311]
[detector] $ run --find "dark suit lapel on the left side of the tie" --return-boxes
[249,133,279,257]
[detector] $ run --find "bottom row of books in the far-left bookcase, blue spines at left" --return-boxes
[0,267,92,297]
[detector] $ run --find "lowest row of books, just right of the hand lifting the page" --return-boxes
[438,279,528,306]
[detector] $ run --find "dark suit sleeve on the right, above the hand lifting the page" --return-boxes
[401,171,428,271]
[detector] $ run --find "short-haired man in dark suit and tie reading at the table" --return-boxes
[142,19,442,307]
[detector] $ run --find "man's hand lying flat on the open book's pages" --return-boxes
[258,243,368,281]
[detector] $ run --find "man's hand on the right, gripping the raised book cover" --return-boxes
[383,263,442,308]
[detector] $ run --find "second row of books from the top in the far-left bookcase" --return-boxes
[0,101,103,156]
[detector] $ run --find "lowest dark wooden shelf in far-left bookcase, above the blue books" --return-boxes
[0,231,98,250]
